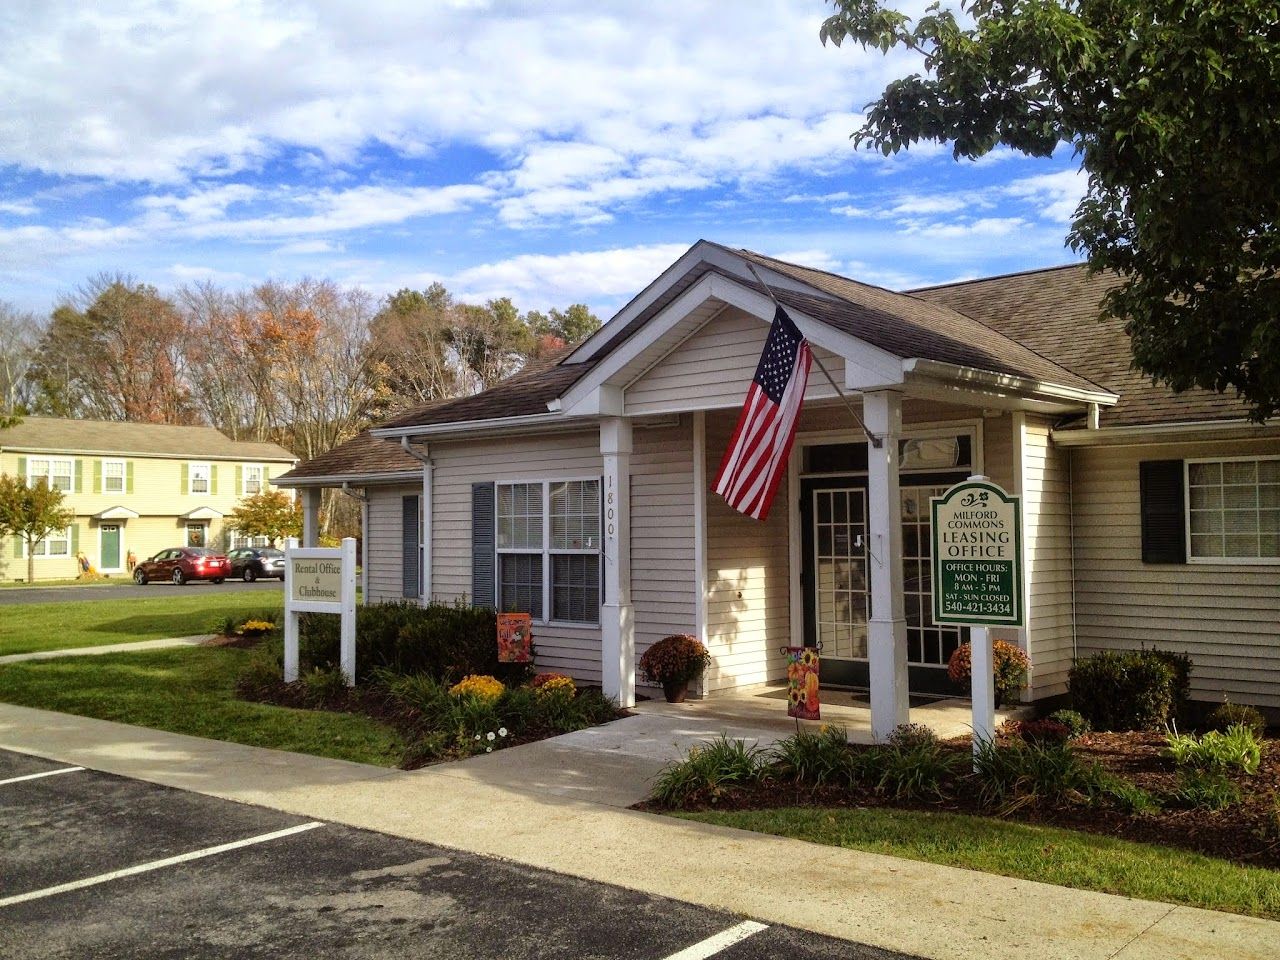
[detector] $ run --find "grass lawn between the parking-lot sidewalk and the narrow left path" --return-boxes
[0,647,404,767]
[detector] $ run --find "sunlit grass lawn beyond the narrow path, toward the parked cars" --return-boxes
[0,586,284,657]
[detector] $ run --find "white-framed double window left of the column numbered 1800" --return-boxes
[495,479,600,623]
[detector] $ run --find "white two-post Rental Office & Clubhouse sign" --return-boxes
[284,536,356,686]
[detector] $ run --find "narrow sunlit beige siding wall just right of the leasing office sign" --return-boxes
[1014,415,1074,699]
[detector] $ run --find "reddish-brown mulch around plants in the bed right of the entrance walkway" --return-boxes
[640,732,1280,869]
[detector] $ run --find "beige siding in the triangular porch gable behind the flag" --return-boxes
[626,308,845,415]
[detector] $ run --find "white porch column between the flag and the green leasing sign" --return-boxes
[863,390,909,742]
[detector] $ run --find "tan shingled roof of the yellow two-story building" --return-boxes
[0,417,297,462]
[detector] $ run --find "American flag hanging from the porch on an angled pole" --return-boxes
[714,306,813,520]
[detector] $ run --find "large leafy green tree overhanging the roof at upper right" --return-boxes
[820,0,1280,419]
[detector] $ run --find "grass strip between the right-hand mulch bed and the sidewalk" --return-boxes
[671,808,1280,920]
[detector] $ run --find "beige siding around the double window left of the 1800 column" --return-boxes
[430,431,603,684]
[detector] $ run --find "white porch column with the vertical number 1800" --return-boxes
[600,417,636,707]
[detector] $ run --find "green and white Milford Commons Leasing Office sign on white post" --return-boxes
[931,476,1025,753]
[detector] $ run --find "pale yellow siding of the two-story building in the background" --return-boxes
[0,451,291,580]
